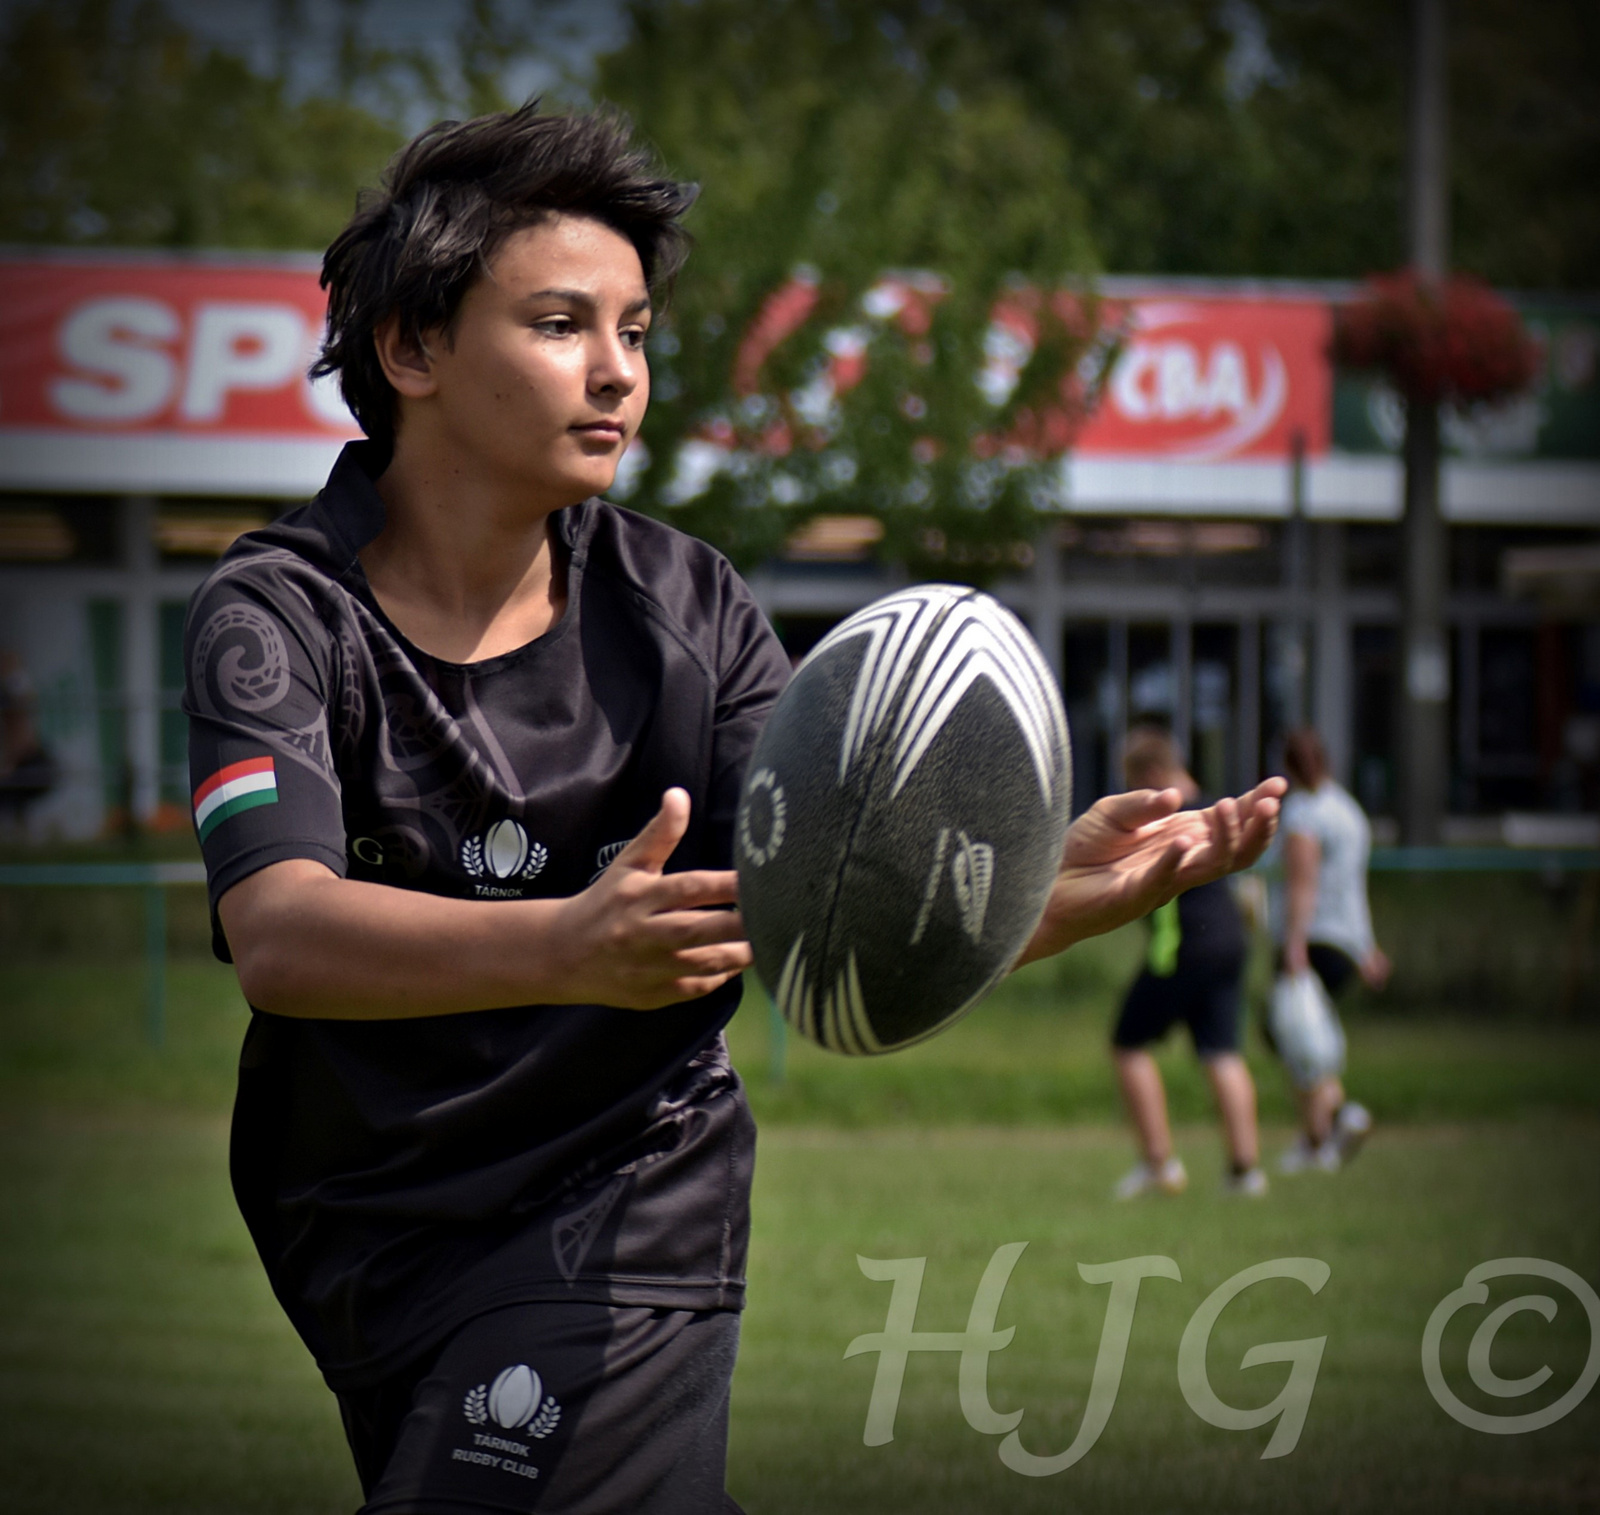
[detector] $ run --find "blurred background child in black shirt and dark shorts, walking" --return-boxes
[1110,726,1267,1200]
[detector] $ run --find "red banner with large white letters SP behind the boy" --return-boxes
[0,259,357,440]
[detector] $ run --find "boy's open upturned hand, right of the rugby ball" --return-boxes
[1018,779,1288,966]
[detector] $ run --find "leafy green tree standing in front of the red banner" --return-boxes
[595,0,1104,578]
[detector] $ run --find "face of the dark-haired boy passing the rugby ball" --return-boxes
[409,216,650,507]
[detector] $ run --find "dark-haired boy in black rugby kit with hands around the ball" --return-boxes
[187,106,1278,1515]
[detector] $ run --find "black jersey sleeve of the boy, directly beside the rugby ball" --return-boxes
[710,565,792,867]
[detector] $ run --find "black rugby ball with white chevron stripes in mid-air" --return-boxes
[734,584,1072,1056]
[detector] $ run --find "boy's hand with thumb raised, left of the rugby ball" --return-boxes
[560,789,752,1009]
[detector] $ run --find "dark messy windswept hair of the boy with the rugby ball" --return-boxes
[312,99,698,443]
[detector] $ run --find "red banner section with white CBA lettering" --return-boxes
[1074,294,1333,462]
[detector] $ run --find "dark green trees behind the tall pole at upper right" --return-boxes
[915,0,1600,290]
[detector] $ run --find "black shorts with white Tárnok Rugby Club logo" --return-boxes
[339,1302,739,1515]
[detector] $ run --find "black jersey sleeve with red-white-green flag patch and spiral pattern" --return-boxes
[184,562,346,960]
